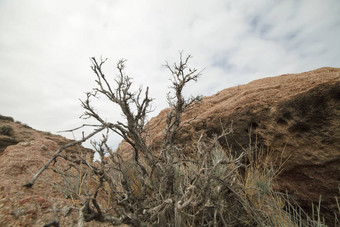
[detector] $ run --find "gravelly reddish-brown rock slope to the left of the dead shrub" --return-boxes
[0,115,110,226]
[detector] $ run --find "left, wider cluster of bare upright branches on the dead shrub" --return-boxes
[81,57,152,166]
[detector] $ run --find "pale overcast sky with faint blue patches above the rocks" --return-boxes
[0,0,340,147]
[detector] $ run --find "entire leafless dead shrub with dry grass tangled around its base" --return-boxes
[26,53,340,226]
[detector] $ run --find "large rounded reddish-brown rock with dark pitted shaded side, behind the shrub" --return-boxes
[120,68,340,223]
